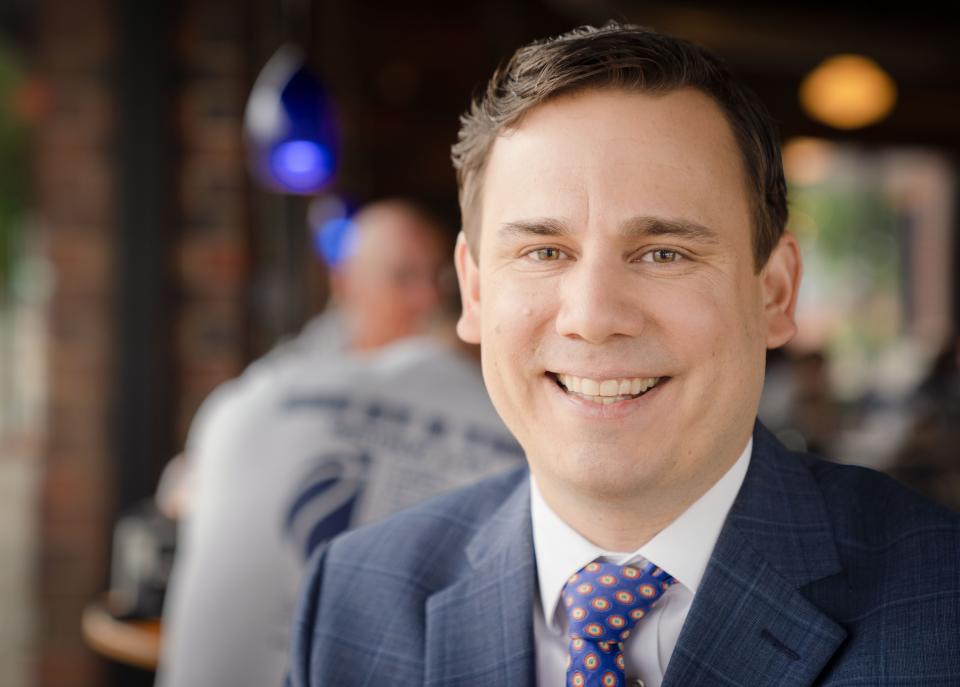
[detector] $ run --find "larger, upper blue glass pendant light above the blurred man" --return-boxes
[244,45,337,195]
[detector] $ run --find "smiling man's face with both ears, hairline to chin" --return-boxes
[457,89,799,506]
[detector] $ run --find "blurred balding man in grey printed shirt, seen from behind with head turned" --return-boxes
[157,195,522,687]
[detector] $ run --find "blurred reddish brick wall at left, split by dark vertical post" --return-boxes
[35,0,250,687]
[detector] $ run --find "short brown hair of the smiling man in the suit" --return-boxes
[452,22,787,271]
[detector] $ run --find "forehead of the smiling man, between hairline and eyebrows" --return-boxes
[481,89,749,242]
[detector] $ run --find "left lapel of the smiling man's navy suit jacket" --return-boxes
[425,479,536,687]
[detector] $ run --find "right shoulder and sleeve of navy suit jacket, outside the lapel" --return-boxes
[805,452,960,685]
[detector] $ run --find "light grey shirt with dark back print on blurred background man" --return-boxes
[161,330,522,687]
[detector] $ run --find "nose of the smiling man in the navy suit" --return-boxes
[556,257,643,343]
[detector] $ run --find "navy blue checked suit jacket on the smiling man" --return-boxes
[288,425,960,687]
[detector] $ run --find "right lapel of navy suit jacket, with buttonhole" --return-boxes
[663,423,846,687]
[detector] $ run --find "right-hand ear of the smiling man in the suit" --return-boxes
[761,233,803,348]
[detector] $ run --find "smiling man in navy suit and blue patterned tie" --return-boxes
[289,24,960,687]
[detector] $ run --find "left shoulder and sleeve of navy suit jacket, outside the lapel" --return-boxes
[289,469,526,685]
